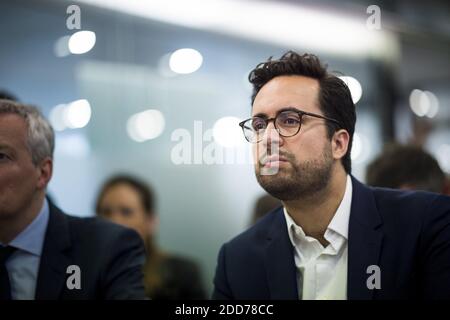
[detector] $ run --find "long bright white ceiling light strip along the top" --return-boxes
[78,0,398,57]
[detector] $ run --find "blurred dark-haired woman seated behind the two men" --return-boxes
[96,175,206,300]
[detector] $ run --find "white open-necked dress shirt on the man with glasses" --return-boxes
[284,175,352,300]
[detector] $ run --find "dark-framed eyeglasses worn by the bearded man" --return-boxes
[239,108,342,143]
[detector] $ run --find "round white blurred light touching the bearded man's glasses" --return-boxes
[213,117,245,148]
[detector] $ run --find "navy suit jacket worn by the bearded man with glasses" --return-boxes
[213,178,450,300]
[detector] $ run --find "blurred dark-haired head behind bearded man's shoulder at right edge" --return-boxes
[366,144,447,193]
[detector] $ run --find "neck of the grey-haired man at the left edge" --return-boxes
[0,194,45,244]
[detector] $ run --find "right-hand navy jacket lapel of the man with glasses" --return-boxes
[347,177,383,300]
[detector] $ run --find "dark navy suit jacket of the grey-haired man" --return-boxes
[35,201,146,300]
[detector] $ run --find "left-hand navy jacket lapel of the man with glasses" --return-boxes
[264,208,298,300]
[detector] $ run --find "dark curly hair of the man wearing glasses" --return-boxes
[248,51,356,173]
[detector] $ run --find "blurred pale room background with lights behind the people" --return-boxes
[0,0,450,291]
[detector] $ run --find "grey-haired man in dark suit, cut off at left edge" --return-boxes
[0,100,145,300]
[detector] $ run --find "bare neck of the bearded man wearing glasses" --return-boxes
[283,168,347,246]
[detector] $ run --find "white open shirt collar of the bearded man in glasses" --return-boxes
[283,175,353,249]
